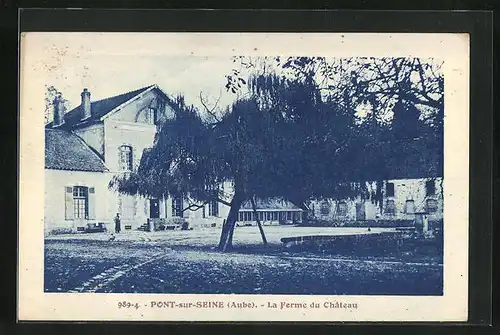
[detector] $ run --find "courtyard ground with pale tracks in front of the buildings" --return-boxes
[45,226,443,295]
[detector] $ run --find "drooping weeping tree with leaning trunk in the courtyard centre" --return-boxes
[110,97,270,251]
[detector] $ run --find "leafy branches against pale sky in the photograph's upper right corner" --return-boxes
[226,56,444,127]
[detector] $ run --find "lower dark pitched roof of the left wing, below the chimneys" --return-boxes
[45,129,108,172]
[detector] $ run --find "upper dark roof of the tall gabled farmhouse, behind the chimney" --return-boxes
[47,85,155,128]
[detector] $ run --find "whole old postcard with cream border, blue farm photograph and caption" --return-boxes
[18,32,469,322]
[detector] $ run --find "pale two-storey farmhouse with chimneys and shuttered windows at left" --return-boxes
[45,85,228,232]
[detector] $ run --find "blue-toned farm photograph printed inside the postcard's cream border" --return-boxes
[40,56,445,296]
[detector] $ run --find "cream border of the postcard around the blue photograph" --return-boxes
[18,33,469,321]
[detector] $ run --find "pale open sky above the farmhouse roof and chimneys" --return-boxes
[46,55,239,112]
